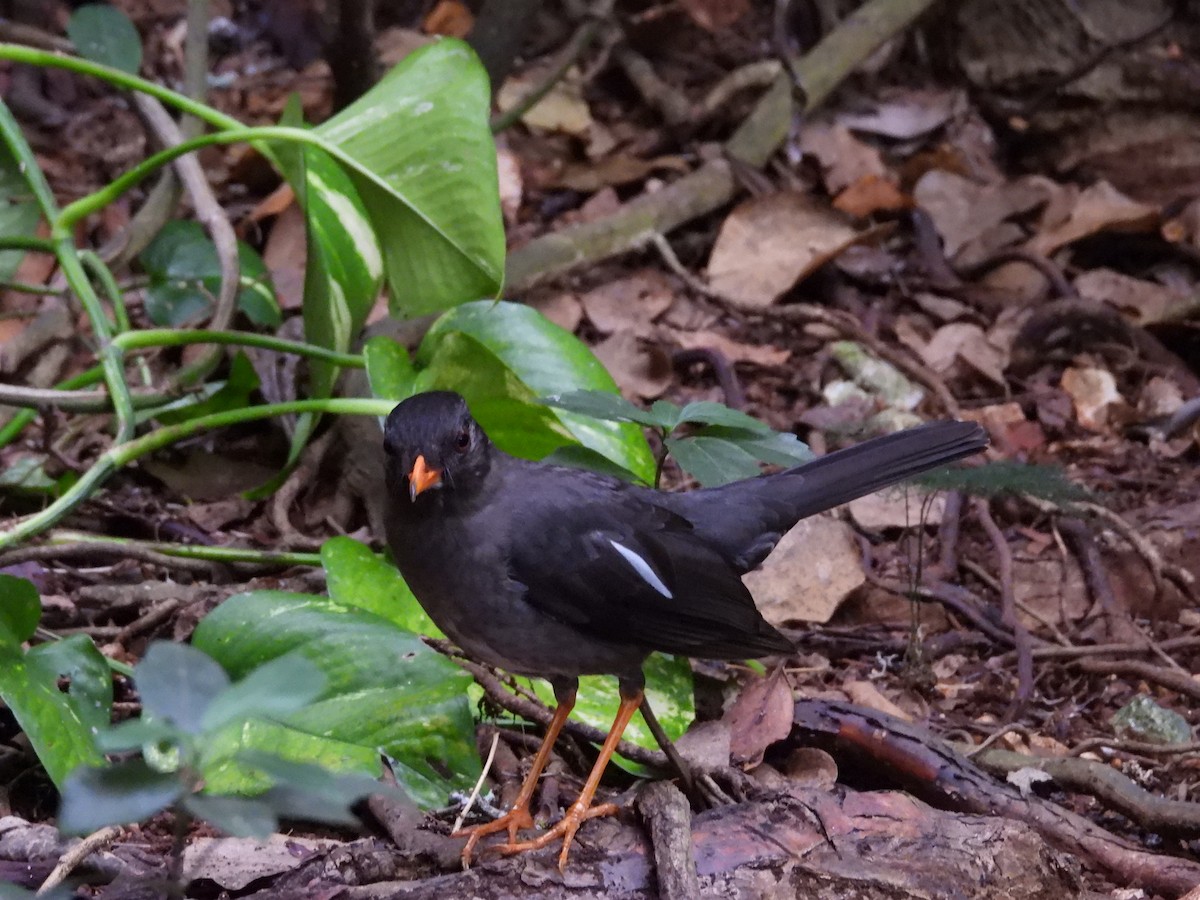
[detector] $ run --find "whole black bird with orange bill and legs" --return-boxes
[383,391,988,870]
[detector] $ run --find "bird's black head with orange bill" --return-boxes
[383,391,492,509]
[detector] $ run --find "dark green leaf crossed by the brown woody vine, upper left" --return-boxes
[138,221,283,328]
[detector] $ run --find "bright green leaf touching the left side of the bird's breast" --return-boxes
[320,538,444,637]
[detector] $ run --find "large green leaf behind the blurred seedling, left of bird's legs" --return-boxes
[192,590,479,805]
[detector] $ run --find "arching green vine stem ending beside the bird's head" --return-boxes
[0,398,395,550]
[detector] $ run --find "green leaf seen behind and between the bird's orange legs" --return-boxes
[532,653,696,774]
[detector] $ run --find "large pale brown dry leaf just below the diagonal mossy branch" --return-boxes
[708,192,859,306]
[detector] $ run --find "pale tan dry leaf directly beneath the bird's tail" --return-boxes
[742,516,866,625]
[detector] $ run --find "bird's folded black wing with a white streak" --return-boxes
[509,473,792,659]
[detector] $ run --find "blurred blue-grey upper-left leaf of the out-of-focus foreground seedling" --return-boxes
[133,641,229,734]
